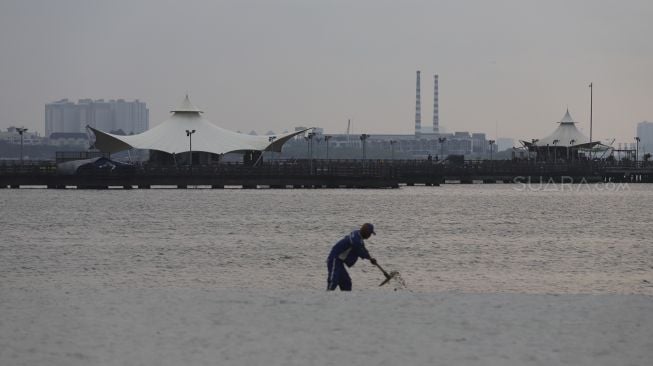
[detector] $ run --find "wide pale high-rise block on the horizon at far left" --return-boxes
[45,99,149,137]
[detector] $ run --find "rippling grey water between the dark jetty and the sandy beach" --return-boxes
[0,185,653,294]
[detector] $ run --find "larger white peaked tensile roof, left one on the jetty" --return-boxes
[87,95,306,154]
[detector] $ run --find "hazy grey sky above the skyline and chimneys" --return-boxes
[0,0,653,142]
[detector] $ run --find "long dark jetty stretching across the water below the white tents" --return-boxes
[0,159,653,189]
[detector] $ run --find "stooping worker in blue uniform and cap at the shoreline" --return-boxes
[327,223,376,291]
